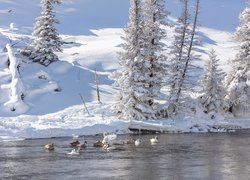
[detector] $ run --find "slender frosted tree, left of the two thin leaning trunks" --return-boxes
[168,0,191,115]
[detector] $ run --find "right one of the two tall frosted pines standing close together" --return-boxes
[140,0,168,118]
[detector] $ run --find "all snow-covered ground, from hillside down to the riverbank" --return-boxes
[0,0,247,140]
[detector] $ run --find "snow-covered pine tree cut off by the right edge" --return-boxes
[226,7,250,114]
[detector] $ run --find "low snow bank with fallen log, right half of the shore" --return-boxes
[128,117,246,133]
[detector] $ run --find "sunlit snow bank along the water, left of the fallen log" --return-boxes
[0,103,128,140]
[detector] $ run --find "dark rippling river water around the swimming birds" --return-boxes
[0,132,250,180]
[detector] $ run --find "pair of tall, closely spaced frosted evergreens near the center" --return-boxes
[111,0,168,119]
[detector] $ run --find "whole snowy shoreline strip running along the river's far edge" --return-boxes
[0,103,250,141]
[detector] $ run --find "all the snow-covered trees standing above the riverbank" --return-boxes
[22,0,250,120]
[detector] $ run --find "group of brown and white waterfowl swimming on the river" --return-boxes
[44,133,159,155]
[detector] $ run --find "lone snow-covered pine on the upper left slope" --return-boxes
[29,0,62,66]
